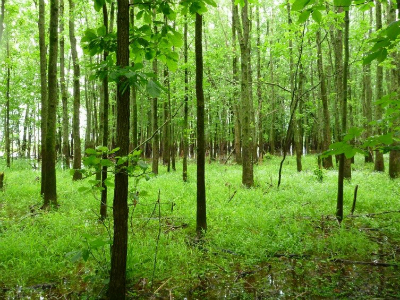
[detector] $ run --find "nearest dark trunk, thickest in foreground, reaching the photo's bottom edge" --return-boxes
[108,0,130,299]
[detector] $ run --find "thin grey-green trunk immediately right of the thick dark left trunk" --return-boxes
[60,0,70,169]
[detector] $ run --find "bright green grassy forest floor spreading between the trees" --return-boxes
[0,156,400,299]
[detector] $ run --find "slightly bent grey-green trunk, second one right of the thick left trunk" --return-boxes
[69,0,82,180]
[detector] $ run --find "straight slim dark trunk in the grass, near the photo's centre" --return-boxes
[195,13,207,236]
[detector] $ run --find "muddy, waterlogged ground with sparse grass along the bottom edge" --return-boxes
[0,256,400,299]
